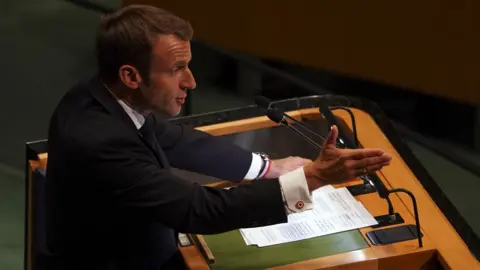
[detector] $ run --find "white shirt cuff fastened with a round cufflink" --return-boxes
[279,167,313,214]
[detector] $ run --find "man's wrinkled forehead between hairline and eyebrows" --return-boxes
[152,35,191,61]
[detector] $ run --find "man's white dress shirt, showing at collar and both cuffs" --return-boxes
[118,100,313,214]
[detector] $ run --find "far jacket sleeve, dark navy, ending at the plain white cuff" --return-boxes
[157,122,252,180]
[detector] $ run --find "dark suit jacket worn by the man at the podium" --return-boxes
[47,77,286,270]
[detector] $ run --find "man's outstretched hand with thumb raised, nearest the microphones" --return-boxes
[304,126,392,191]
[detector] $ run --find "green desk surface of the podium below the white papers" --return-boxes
[203,230,369,270]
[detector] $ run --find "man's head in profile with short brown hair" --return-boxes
[96,5,195,116]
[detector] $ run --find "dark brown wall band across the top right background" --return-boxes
[126,0,480,104]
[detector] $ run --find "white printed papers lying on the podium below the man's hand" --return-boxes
[240,186,377,247]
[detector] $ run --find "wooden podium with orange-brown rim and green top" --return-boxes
[26,96,480,269]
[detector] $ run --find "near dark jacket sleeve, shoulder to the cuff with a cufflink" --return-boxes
[77,133,286,234]
